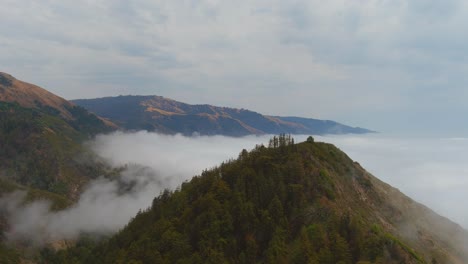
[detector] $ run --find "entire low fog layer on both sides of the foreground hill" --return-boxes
[0,131,468,244]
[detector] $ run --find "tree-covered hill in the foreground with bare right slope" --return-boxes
[42,135,468,264]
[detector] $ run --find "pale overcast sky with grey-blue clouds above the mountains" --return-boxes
[0,0,468,136]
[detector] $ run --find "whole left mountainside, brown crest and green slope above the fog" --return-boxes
[0,73,115,199]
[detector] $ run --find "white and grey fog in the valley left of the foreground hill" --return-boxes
[0,132,274,245]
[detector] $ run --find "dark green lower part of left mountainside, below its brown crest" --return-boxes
[0,102,111,197]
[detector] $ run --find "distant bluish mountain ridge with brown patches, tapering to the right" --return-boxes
[73,96,372,136]
